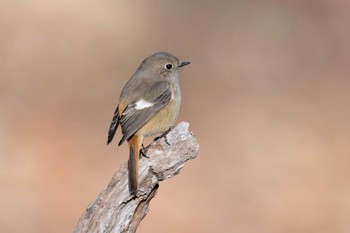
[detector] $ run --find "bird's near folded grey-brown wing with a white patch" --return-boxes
[119,81,172,145]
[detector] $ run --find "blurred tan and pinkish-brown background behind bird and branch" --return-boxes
[0,0,350,233]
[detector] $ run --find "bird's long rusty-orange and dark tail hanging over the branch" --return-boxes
[128,135,143,195]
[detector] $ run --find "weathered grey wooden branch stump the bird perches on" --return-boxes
[74,122,199,233]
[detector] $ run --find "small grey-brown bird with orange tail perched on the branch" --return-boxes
[107,52,190,195]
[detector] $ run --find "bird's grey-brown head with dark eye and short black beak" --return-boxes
[139,52,190,77]
